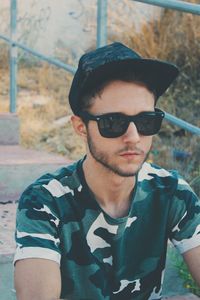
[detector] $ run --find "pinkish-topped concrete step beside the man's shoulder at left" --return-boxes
[0,145,70,202]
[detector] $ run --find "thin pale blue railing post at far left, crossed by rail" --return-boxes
[10,0,17,113]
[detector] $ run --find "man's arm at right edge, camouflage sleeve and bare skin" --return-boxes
[169,179,200,286]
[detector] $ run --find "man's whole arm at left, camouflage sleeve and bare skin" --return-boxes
[14,185,61,300]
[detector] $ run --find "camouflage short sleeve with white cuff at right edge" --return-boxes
[169,177,200,253]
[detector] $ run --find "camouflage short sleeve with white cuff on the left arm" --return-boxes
[14,185,61,264]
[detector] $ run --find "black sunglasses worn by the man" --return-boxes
[80,108,165,138]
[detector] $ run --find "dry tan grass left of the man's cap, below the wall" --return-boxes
[0,63,84,159]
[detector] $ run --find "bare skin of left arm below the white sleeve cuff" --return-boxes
[15,258,61,300]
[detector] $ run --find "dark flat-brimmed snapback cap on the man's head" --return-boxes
[69,42,179,115]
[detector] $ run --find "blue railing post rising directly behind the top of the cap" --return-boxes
[97,0,108,48]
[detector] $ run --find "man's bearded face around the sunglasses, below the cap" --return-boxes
[84,81,155,177]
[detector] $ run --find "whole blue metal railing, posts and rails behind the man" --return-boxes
[0,0,200,136]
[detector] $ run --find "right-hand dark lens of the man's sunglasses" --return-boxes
[135,114,163,135]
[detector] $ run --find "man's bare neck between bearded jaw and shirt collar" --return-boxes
[83,157,135,218]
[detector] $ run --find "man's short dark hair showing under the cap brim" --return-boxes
[79,69,158,113]
